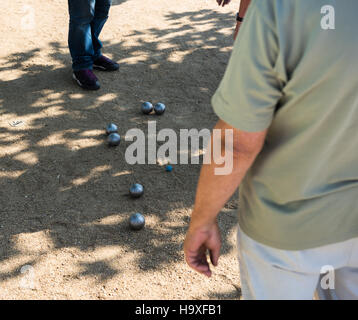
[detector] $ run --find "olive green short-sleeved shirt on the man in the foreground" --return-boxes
[212,0,358,250]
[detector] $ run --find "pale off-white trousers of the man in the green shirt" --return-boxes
[237,228,358,300]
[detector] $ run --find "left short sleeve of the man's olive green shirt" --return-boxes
[212,0,282,132]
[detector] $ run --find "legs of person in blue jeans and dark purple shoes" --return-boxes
[68,0,119,90]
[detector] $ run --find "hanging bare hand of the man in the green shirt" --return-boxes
[184,220,221,277]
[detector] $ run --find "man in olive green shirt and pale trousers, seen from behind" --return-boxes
[184,0,358,299]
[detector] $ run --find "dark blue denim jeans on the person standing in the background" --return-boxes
[68,0,112,71]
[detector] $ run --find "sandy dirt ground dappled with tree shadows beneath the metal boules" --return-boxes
[0,0,240,299]
